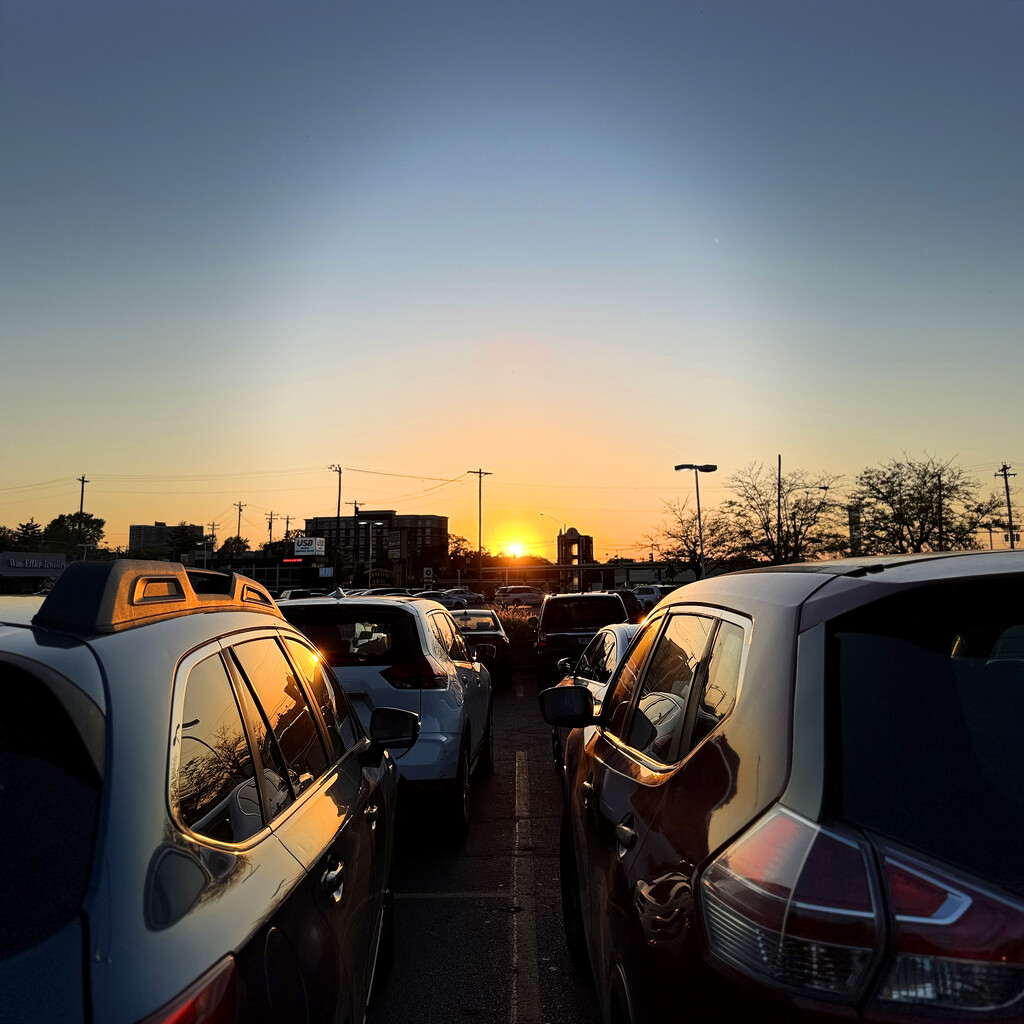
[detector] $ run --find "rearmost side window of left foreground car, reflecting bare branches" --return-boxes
[175,656,263,843]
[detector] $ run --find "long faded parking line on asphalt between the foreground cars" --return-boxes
[510,751,541,1024]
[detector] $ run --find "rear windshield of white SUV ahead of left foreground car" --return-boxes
[281,600,422,668]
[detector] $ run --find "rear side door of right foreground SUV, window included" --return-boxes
[585,614,715,1011]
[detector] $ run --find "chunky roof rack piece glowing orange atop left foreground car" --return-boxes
[32,558,283,633]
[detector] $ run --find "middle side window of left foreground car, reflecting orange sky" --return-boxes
[231,639,328,794]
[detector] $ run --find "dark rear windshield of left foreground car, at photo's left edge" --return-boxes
[0,663,103,961]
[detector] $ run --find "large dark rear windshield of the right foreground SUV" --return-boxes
[828,580,1024,891]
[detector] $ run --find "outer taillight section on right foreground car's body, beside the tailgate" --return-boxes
[699,807,882,1002]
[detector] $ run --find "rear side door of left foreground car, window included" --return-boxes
[230,636,377,1021]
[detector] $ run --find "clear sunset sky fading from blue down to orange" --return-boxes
[0,0,1024,558]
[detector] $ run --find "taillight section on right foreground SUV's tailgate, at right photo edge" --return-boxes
[879,852,1024,1011]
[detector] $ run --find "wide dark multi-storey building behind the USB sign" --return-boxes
[305,509,449,582]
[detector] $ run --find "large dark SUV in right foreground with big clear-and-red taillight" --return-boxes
[541,552,1024,1022]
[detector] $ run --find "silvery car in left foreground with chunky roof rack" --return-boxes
[0,559,419,1024]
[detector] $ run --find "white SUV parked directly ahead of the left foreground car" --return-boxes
[282,595,494,840]
